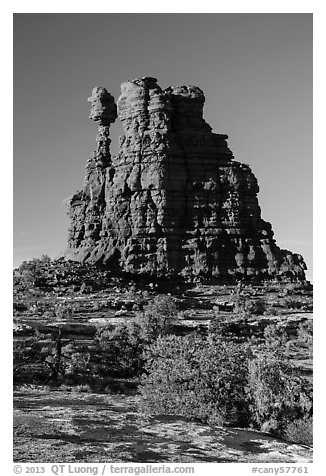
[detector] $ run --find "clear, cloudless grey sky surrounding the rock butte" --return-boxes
[13,13,313,279]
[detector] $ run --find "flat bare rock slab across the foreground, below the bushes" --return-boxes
[14,388,312,463]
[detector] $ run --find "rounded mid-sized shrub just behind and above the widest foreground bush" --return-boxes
[136,295,178,342]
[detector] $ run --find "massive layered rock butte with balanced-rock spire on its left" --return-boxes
[66,77,306,281]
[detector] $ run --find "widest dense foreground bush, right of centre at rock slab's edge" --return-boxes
[140,335,249,424]
